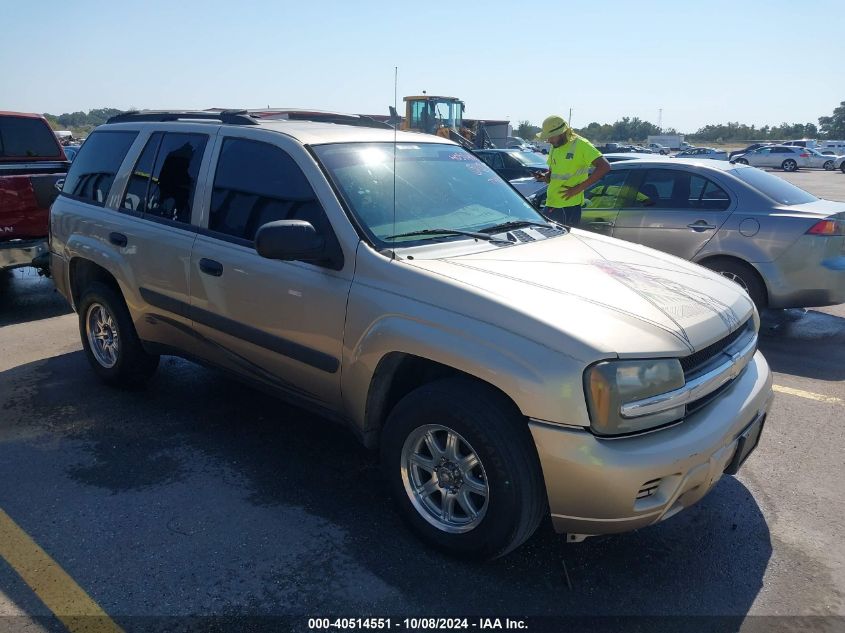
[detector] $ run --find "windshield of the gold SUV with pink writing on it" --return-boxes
[314,143,545,248]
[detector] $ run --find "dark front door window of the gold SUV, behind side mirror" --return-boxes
[208,138,329,242]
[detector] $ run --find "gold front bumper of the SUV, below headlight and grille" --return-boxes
[529,352,773,535]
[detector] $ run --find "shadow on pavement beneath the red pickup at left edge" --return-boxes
[0,268,72,327]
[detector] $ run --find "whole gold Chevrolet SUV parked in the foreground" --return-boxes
[51,111,772,558]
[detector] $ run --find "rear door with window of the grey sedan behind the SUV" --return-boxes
[613,168,735,259]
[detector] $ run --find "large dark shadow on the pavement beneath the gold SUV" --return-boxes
[0,352,772,631]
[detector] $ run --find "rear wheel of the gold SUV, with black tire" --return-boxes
[78,282,159,387]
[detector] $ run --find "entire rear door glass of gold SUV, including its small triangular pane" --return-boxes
[140,132,208,224]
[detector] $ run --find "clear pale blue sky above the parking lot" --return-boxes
[0,0,845,132]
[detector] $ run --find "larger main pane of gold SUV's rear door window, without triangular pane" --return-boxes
[143,132,208,224]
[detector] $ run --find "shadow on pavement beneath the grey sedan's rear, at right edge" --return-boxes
[760,309,845,381]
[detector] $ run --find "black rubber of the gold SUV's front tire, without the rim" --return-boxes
[381,377,548,560]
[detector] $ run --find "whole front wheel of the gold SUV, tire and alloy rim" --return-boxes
[381,378,547,559]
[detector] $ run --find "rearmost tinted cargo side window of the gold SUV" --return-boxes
[62,131,138,204]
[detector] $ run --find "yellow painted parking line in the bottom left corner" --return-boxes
[0,508,123,633]
